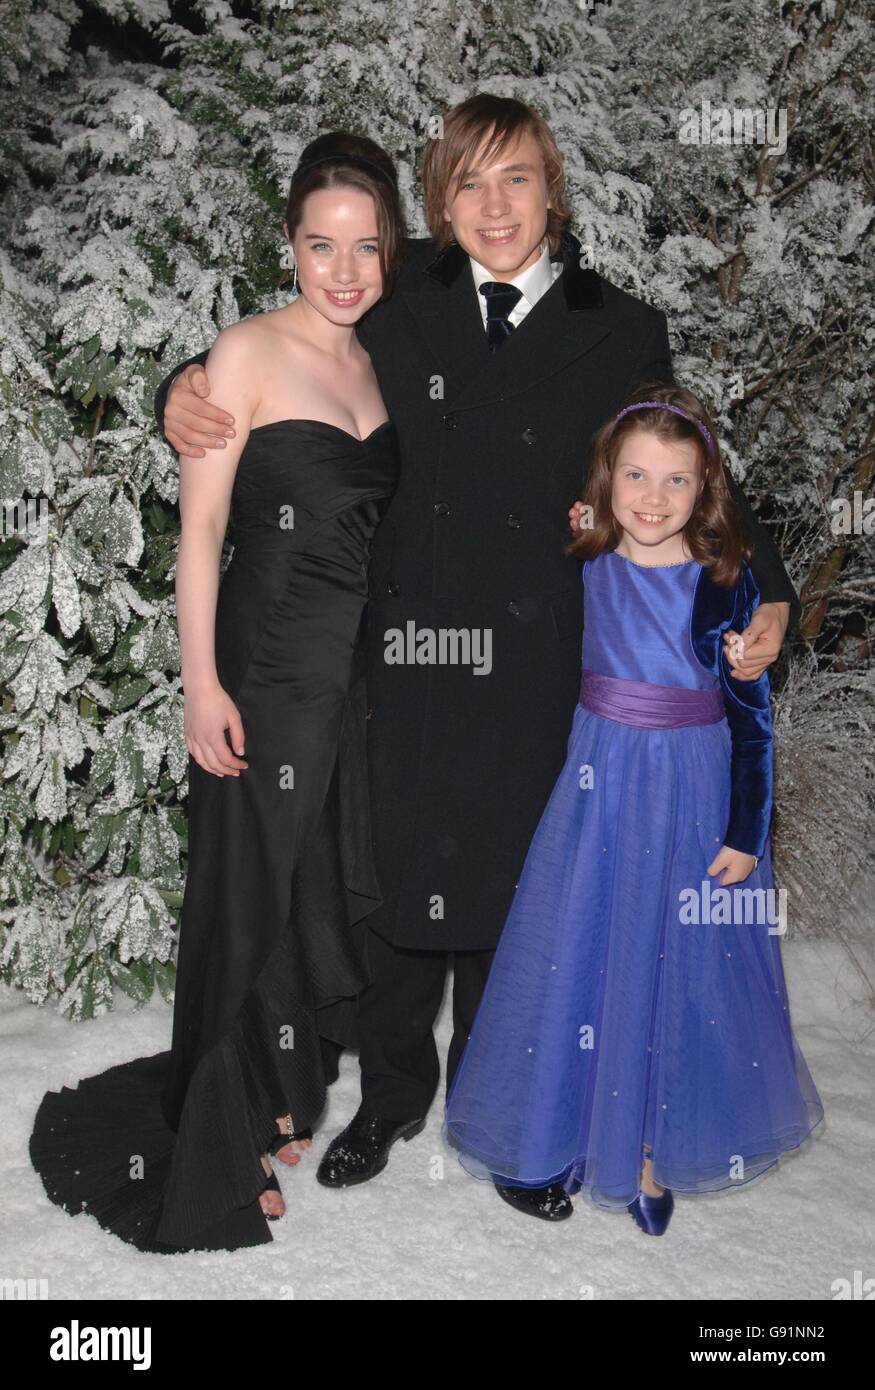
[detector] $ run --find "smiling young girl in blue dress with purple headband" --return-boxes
[444,386,824,1234]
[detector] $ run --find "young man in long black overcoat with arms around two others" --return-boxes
[156,95,798,1220]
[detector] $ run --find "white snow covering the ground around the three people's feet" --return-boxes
[0,941,875,1300]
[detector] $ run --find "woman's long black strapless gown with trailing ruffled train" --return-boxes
[31,420,398,1252]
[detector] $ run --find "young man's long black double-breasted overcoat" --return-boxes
[156,234,798,951]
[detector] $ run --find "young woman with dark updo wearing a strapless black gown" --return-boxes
[31,132,402,1252]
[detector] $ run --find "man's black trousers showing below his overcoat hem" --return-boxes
[358,931,495,1120]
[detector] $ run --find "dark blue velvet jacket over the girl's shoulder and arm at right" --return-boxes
[690,564,773,858]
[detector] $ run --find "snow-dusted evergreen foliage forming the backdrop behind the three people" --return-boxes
[0,0,875,1016]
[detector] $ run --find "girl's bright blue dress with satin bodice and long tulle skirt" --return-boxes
[444,552,824,1207]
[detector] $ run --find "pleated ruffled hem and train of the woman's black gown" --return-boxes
[29,678,381,1254]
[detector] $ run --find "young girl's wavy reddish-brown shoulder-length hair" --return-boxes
[565,382,751,587]
